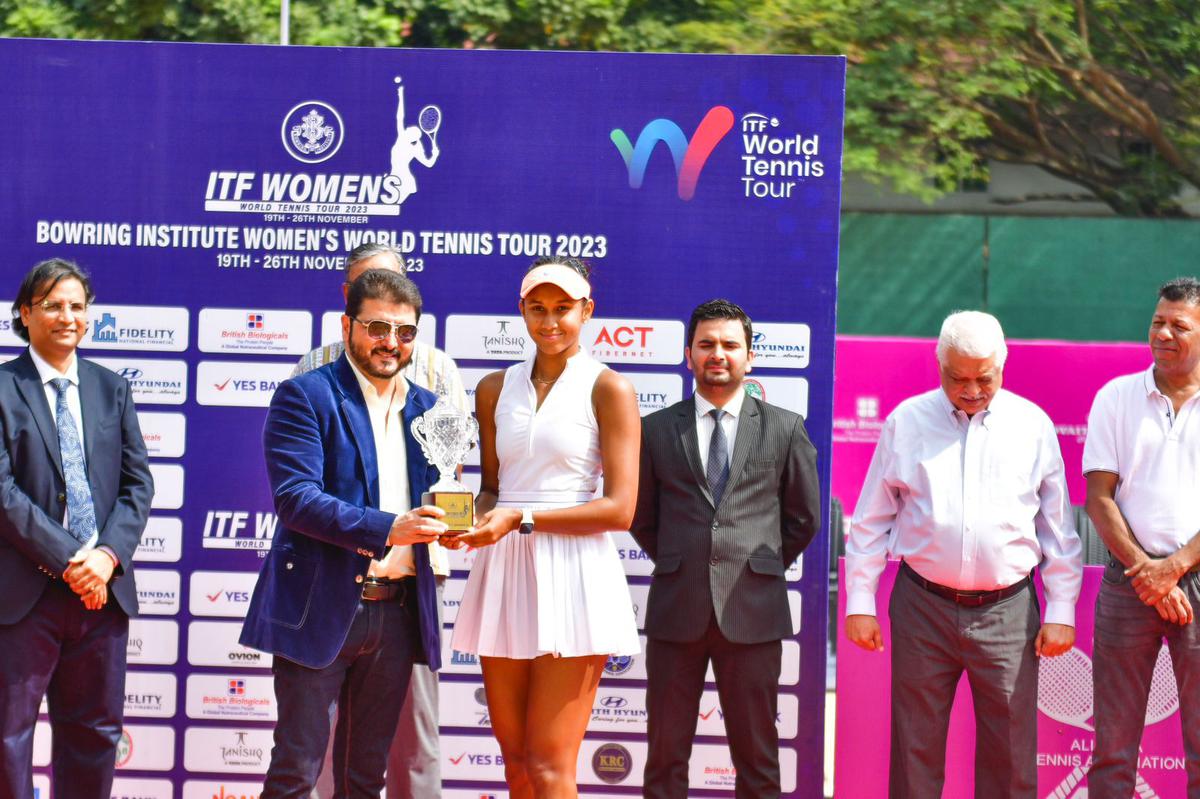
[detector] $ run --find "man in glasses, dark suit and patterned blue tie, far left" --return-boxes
[0,258,154,799]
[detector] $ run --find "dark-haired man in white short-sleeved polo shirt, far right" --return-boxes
[1084,277,1200,799]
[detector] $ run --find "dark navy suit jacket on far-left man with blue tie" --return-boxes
[0,350,154,624]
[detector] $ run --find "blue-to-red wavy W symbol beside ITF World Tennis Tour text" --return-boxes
[608,106,733,200]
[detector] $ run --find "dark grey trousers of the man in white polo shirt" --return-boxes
[1087,561,1200,799]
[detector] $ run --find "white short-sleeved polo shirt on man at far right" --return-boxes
[1084,366,1200,557]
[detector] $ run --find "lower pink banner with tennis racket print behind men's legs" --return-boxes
[834,563,1187,799]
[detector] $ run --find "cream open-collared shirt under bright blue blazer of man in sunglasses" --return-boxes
[346,356,416,579]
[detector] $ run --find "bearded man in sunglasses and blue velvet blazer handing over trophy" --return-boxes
[241,270,446,799]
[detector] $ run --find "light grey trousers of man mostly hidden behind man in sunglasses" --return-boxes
[312,577,446,799]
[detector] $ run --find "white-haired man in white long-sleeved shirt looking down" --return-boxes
[846,311,1082,799]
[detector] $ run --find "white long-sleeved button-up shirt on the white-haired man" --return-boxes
[846,389,1082,625]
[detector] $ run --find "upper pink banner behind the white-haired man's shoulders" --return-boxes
[832,336,1150,506]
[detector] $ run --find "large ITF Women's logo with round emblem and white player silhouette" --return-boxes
[204,76,442,222]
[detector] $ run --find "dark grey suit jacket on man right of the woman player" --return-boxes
[631,396,821,643]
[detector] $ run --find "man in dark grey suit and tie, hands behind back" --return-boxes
[632,300,821,799]
